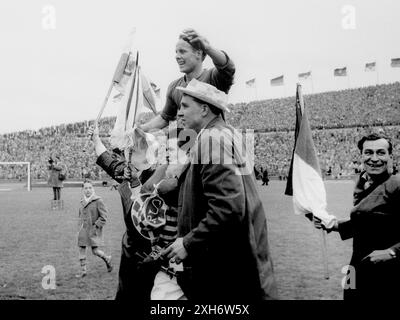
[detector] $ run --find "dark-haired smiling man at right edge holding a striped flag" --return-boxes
[316,134,400,299]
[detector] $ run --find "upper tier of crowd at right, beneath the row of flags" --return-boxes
[227,82,400,131]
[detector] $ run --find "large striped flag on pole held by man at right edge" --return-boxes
[285,84,336,228]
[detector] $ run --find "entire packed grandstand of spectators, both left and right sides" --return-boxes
[0,82,400,180]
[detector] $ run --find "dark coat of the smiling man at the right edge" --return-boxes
[339,173,400,299]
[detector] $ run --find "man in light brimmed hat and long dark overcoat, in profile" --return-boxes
[164,79,276,301]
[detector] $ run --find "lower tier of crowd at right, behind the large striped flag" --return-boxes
[254,126,400,179]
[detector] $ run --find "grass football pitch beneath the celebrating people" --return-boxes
[0,181,353,300]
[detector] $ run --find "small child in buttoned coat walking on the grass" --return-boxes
[76,180,113,278]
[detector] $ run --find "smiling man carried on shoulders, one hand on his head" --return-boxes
[141,29,235,132]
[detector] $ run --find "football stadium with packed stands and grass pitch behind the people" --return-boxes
[0,83,400,299]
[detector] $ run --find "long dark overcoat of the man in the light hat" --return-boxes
[178,117,277,301]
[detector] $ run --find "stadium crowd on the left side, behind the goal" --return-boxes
[0,119,115,180]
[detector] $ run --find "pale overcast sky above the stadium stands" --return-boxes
[0,0,400,134]
